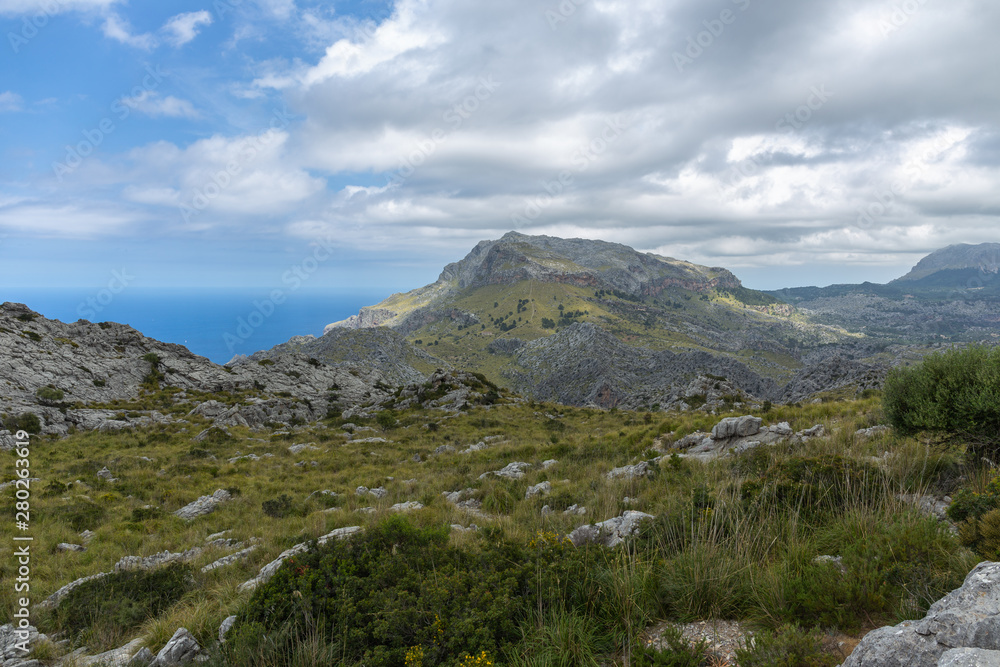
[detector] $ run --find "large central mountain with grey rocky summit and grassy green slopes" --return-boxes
[320,232,885,407]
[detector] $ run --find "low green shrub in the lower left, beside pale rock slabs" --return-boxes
[53,563,194,649]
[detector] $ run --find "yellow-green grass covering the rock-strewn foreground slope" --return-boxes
[0,394,977,665]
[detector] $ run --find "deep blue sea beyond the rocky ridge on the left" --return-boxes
[0,288,389,364]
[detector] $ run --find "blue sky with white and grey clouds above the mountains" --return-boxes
[0,0,1000,300]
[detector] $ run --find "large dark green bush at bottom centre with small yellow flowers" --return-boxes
[224,517,600,666]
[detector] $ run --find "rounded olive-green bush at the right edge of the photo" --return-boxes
[882,346,1000,444]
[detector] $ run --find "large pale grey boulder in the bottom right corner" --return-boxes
[843,561,1000,667]
